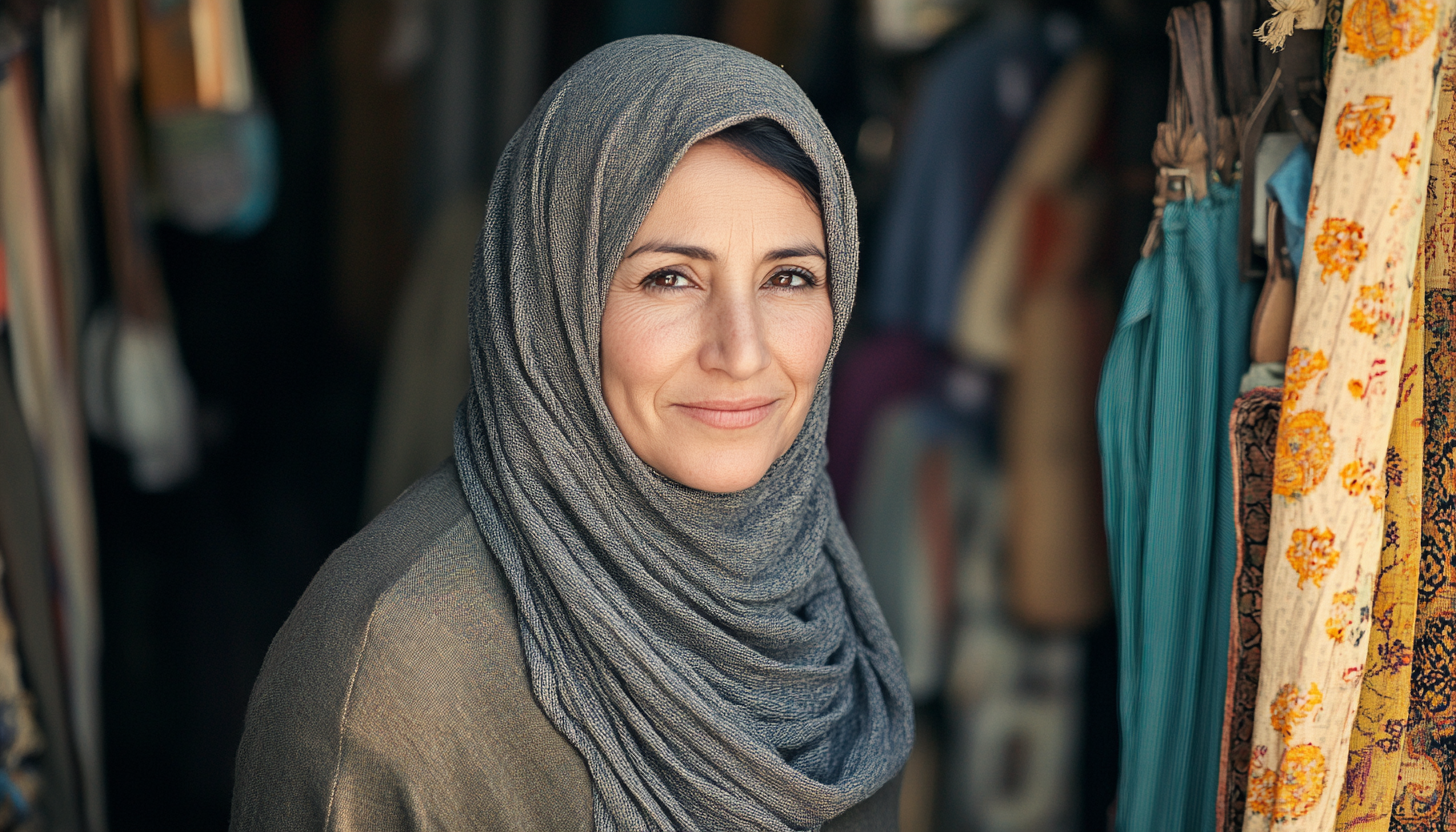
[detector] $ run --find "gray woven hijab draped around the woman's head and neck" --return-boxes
[454,36,913,831]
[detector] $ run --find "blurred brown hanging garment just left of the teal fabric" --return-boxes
[1002,189,1112,631]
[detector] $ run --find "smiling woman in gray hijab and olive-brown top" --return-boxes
[233,36,913,832]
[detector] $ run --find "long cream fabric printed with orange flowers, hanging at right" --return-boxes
[1245,0,1452,832]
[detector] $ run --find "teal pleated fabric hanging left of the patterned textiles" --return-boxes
[1098,182,1255,832]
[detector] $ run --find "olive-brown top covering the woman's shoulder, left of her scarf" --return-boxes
[233,462,591,829]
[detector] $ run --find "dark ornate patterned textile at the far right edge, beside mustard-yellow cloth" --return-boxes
[1389,52,1456,832]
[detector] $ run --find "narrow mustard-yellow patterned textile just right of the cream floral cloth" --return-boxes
[1332,269,1425,832]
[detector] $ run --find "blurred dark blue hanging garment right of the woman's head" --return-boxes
[866,9,1076,344]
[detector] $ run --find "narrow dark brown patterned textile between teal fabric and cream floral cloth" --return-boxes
[1214,388,1281,832]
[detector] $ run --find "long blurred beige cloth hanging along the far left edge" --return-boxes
[0,55,105,829]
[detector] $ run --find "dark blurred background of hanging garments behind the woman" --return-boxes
[0,0,1188,832]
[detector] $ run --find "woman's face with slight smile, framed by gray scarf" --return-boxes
[601,140,834,492]
